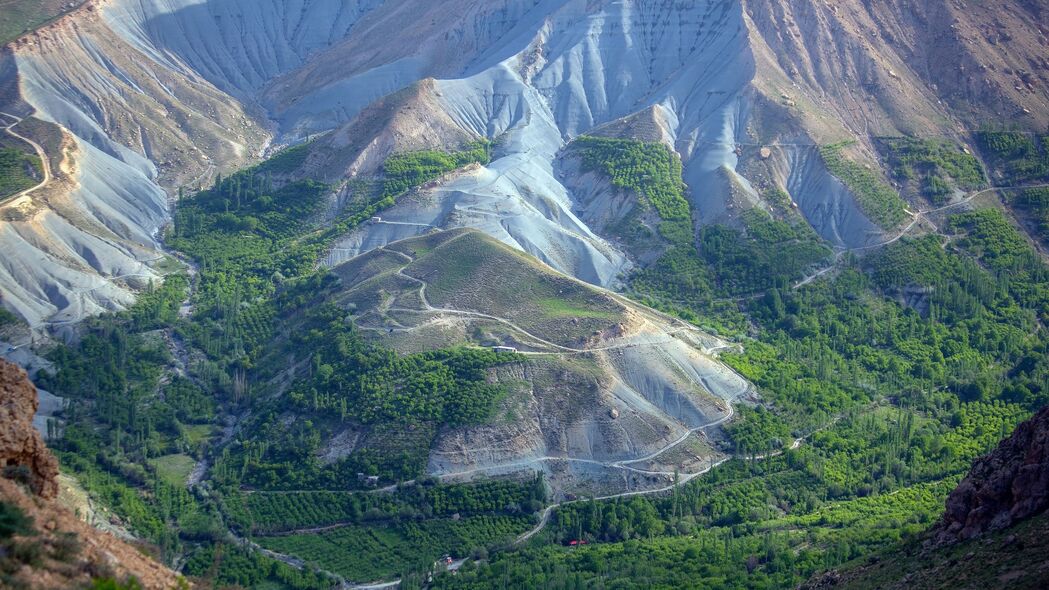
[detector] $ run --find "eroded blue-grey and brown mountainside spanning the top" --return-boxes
[3,0,1047,324]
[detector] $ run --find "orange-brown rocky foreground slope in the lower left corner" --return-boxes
[0,360,180,590]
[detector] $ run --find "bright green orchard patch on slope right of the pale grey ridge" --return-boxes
[572,135,692,244]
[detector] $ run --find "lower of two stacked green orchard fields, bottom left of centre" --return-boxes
[256,517,532,581]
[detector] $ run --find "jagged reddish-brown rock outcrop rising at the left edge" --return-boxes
[0,360,59,500]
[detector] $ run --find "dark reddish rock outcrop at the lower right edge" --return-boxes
[935,407,1049,544]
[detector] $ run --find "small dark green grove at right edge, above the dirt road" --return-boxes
[977,128,1049,185]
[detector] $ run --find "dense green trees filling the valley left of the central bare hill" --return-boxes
[38,142,501,566]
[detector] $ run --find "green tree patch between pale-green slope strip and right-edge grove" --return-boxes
[877,136,986,205]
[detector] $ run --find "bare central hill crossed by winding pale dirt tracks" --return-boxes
[335,230,748,492]
